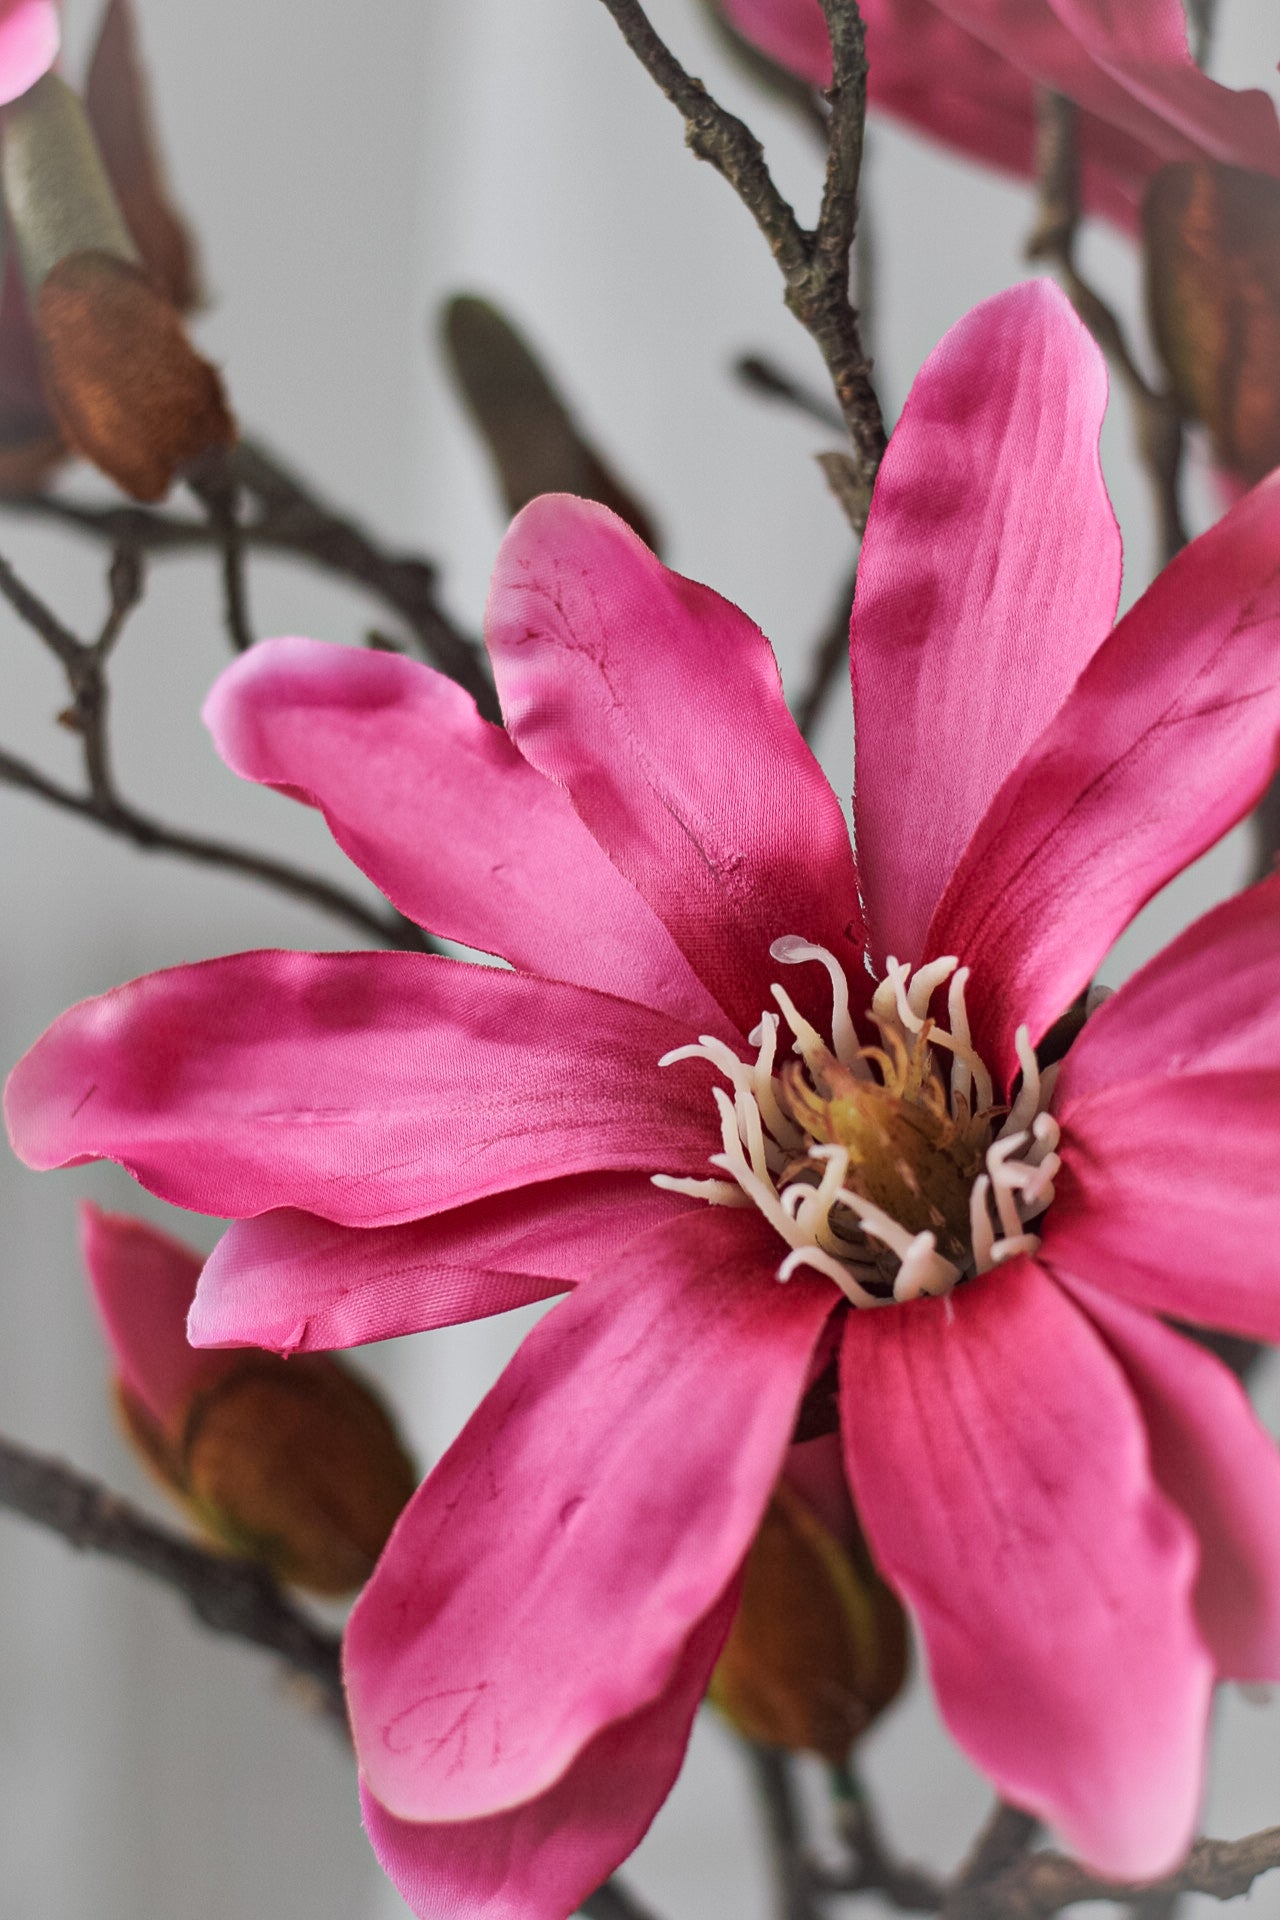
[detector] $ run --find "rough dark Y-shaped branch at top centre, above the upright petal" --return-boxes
[603,0,885,522]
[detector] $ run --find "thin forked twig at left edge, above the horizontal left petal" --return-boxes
[0,545,432,952]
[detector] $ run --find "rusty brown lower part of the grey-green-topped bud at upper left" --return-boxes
[35,253,236,499]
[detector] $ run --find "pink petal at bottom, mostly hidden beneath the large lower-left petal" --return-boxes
[361,1588,737,1920]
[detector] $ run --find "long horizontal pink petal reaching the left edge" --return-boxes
[6,952,718,1227]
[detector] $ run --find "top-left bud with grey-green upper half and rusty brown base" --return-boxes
[0,73,236,499]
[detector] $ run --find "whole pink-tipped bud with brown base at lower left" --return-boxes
[81,1206,416,1594]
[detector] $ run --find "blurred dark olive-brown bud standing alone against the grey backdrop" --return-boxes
[443,294,658,551]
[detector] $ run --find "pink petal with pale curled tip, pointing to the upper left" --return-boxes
[205,639,723,1033]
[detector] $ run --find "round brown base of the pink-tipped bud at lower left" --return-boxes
[177,1354,416,1594]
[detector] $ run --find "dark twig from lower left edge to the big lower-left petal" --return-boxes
[0,1440,345,1726]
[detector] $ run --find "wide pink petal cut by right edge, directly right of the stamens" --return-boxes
[1038,1068,1280,1340]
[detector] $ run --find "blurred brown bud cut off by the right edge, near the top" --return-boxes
[1144,161,1280,486]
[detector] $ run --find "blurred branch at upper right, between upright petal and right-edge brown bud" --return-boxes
[1027,92,1186,566]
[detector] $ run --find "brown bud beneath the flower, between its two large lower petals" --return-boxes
[708,1480,908,1766]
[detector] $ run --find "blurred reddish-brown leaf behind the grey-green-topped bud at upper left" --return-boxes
[84,0,200,313]
